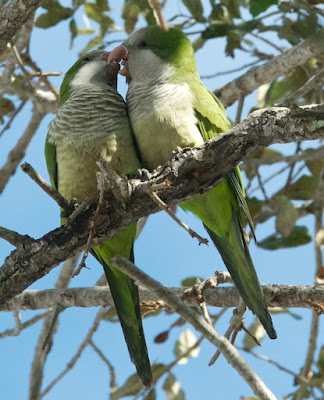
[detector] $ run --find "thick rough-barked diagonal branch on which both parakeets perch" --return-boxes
[0,106,324,303]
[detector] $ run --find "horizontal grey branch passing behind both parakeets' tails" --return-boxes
[0,285,324,311]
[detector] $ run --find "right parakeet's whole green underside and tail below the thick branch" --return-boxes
[179,183,277,339]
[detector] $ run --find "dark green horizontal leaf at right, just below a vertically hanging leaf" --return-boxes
[257,226,312,250]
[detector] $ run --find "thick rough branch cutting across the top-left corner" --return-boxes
[0,0,42,54]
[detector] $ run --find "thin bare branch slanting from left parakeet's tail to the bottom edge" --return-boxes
[112,257,276,400]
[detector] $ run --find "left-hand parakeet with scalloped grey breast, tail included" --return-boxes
[45,51,152,386]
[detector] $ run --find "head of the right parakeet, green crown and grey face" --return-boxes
[108,26,197,81]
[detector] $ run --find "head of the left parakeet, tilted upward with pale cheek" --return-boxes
[60,50,119,106]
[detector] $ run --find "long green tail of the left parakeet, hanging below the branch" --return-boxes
[93,224,153,388]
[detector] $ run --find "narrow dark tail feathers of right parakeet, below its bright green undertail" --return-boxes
[204,217,277,339]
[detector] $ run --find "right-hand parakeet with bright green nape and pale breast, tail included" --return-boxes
[109,26,277,339]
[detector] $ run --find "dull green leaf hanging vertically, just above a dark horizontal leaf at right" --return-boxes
[275,196,298,237]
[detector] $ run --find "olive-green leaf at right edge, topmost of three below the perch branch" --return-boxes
[278,175,318,200]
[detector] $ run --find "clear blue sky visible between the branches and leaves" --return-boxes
[0,1,324,400]
